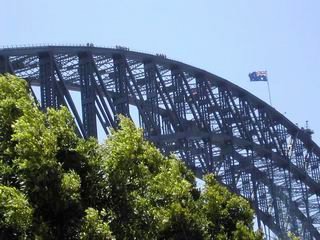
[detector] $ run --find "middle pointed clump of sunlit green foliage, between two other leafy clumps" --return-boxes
[102,117,202,239]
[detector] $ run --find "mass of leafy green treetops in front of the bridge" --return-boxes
[0,75,262,240]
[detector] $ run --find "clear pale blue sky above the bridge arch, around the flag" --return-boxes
[0,0,320,144]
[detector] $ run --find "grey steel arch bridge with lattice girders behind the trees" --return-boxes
[0,44,320,239]
